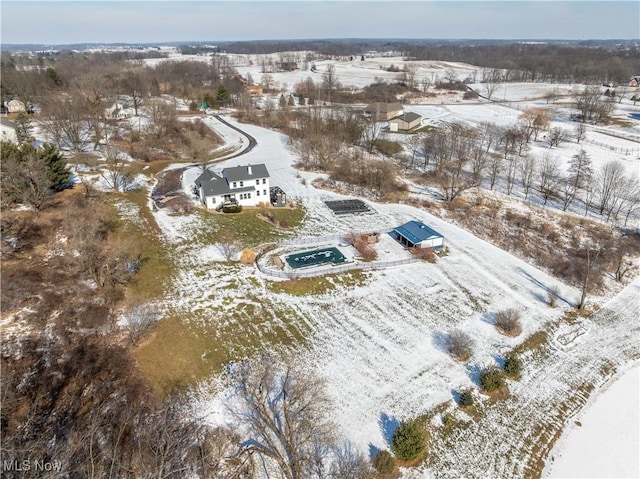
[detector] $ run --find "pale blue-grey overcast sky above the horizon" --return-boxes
[0,0,640,45]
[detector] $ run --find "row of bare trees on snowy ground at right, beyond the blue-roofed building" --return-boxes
[407,120,640,224]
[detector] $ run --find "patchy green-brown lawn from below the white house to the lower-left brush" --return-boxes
[126,192,309,396]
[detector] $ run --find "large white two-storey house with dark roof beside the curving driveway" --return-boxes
[195,164,271,209]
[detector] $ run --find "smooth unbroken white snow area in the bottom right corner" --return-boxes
[545,365,640,479]
